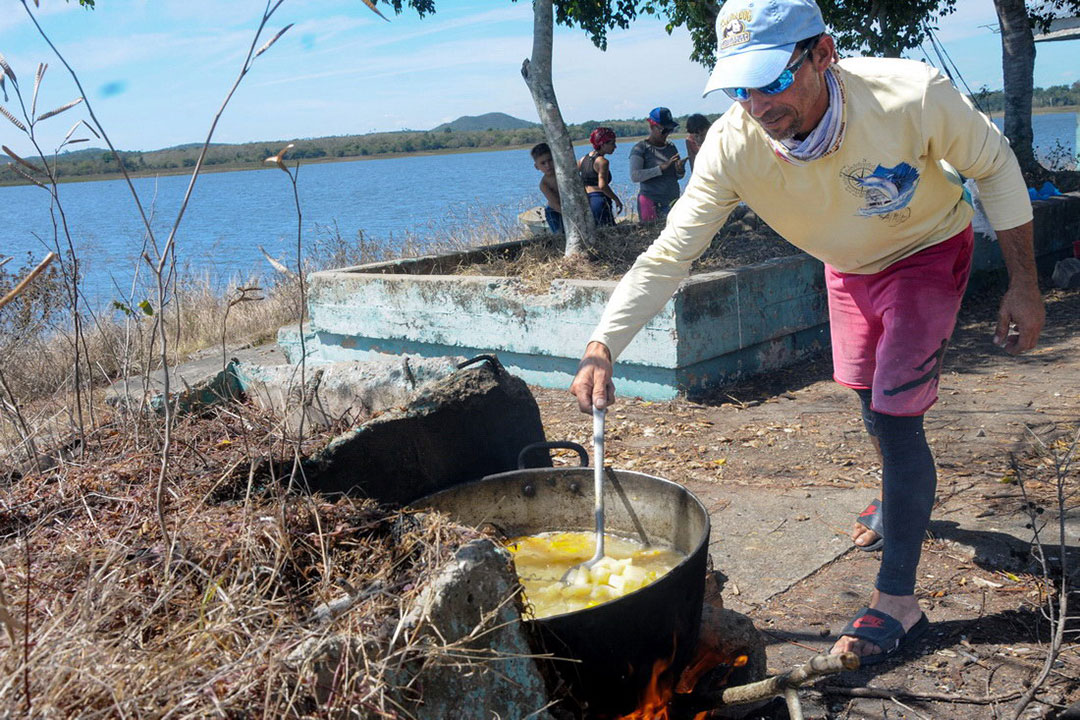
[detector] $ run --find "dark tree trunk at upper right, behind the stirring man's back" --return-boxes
[994,0,1042,177]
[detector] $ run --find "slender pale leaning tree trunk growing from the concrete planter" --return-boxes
[522,0,596,256]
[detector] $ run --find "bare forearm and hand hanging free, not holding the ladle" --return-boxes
[994,222,1047,355]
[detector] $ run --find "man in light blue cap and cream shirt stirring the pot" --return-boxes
[570,0,1044,665]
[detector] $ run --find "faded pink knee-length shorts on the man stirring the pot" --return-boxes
[825,226,974,416]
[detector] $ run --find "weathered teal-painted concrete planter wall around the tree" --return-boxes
[279,193,1080,399]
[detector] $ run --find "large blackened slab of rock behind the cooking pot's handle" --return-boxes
[305,358,551,504]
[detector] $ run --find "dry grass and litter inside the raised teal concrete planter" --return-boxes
[458,206,800,293]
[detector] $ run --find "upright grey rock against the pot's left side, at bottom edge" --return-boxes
[394,540,552,720]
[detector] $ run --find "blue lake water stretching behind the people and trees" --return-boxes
[0,113,1077,304]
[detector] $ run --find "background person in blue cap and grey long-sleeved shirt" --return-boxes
[630,108,686,222]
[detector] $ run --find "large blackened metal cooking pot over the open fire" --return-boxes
[413,447,710,718]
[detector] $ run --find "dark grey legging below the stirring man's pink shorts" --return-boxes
[855,390,937,595]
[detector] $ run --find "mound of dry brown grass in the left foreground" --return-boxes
[0,406,490,718]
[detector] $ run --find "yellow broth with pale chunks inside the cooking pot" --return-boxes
[508,532,686,620]
